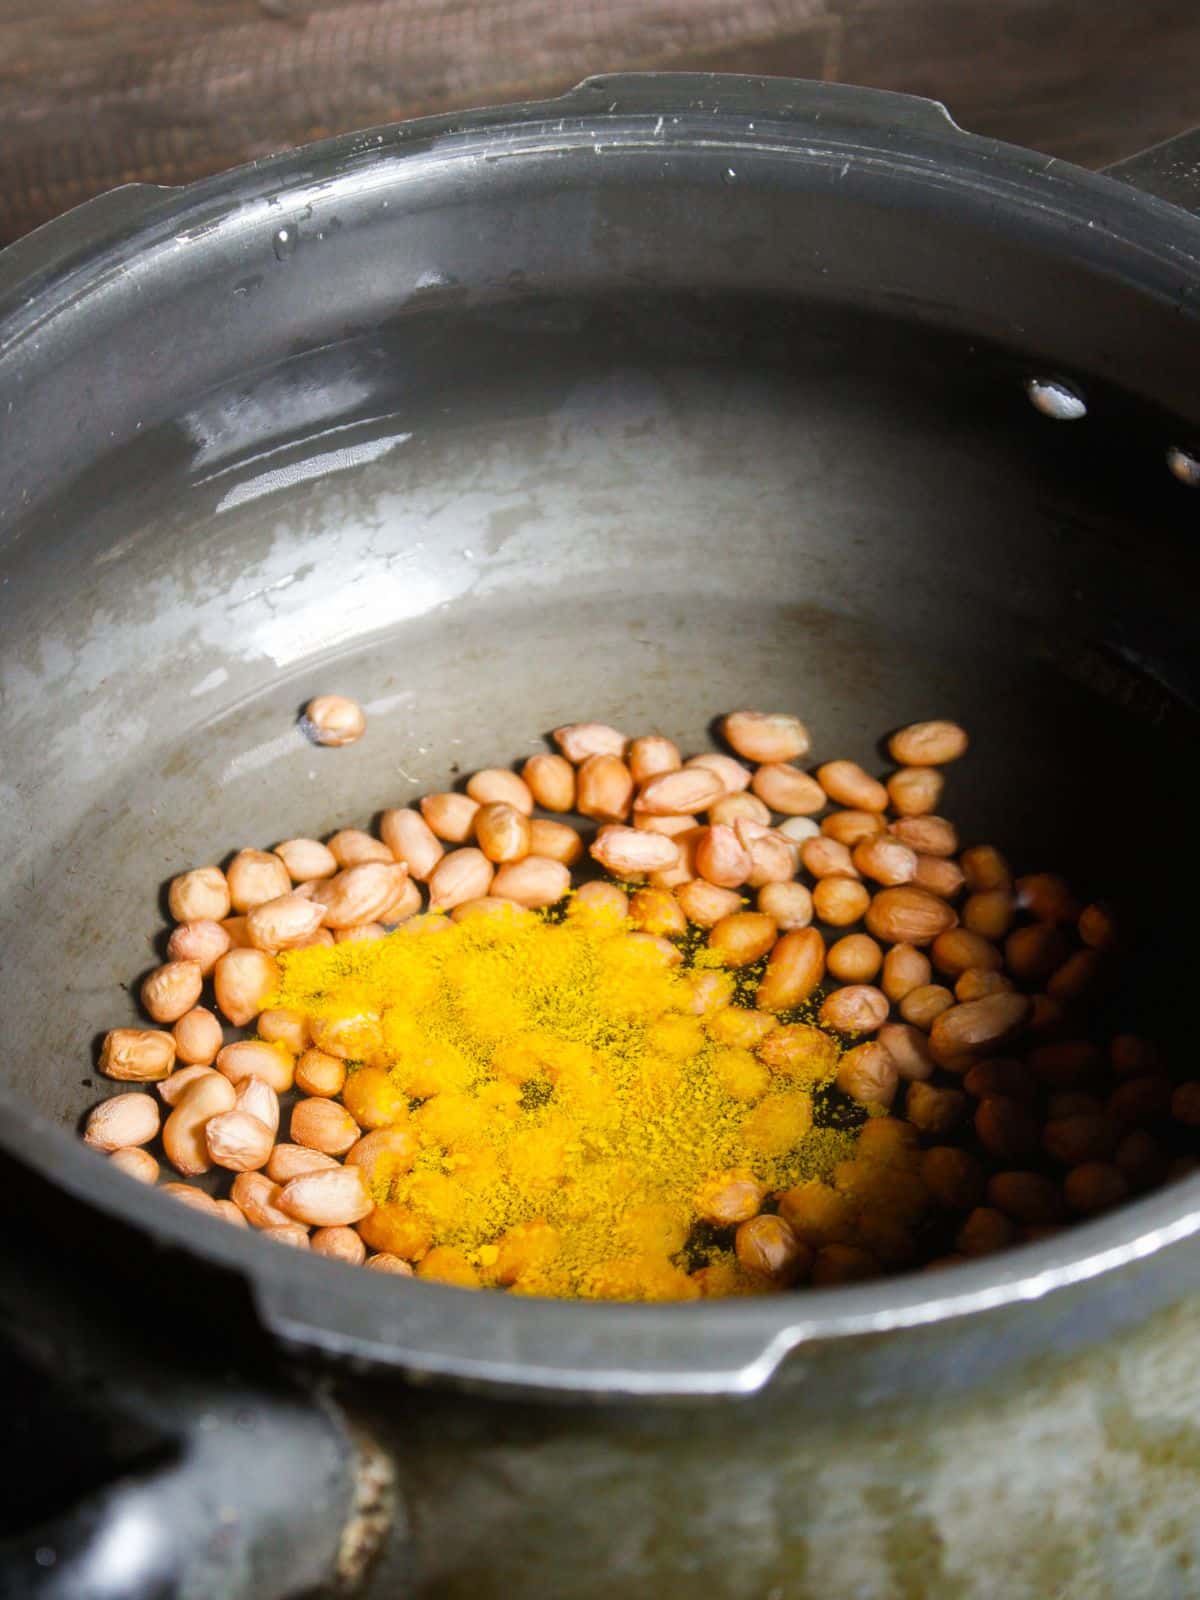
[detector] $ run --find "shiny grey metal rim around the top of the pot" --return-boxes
[0,74,1200,1398]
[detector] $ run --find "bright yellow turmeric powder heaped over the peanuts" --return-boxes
[270,906,853,1299]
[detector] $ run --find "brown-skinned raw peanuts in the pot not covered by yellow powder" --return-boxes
[85,696,1200,1283]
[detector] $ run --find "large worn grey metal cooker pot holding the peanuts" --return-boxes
[0,77,1200,1600]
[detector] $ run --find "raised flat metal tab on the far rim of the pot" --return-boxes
[550,72,968,138]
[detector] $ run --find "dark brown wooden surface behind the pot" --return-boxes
[0,0,1200,243]
